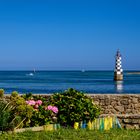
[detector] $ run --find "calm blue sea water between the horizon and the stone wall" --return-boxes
[0,71,140,94]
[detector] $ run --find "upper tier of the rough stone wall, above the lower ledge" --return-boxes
[90,94,140,114]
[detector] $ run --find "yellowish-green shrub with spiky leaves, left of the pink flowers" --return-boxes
[0,95,33,131]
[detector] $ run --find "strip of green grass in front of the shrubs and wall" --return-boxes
[0,129,140,140]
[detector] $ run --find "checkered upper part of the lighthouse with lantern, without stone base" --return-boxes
[115,51,123,74]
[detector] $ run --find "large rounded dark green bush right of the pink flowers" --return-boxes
[48,89,100,126]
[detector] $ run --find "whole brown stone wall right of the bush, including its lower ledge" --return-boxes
[90,94,140,129]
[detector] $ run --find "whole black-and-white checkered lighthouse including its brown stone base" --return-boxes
[114,50,123,81]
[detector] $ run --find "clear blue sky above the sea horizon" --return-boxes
[0,0,140,70]
